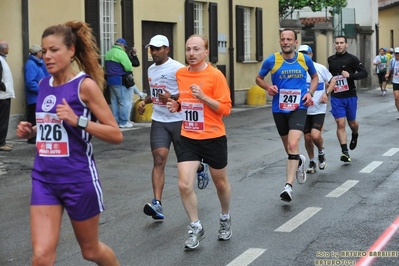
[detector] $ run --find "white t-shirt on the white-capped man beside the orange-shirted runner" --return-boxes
[148,58,184,122]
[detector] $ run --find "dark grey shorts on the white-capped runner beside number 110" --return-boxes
[150,120,182,152]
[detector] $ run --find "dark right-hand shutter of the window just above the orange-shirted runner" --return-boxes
[209,2,219,63]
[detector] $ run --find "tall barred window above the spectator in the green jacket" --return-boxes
[99,0,116,63]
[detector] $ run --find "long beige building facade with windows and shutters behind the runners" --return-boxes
[0,0,279,138]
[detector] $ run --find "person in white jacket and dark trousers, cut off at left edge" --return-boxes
[0,40,15,151]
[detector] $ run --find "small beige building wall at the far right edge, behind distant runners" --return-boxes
[378,6,399,48]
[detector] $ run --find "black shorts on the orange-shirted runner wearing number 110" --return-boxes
[177,136,227,169]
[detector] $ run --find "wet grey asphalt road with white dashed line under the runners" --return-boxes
[0,86,399,266]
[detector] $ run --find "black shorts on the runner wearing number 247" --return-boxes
[273,109,308,136]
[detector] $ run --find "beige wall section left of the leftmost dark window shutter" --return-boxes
[0,0,84,138]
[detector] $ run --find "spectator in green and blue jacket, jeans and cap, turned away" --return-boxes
[104,38,133,128]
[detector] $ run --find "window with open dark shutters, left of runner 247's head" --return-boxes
[236,5,263,62]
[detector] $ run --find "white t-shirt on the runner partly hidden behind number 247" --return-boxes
[306,62,333,115]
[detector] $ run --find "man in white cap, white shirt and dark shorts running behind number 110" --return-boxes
[138,35,209,220]
